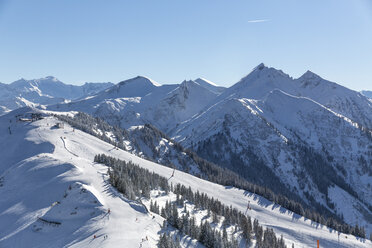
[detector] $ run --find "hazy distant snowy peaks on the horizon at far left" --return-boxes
[0,76,113,115]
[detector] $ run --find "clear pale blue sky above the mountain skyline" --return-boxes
[0,0,372,90]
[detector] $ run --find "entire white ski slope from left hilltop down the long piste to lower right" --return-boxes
[0,110,372,248]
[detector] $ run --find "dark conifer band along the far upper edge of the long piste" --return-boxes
[56,112,366,238]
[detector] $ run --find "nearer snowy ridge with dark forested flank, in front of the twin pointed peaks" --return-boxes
[174,90,372,234]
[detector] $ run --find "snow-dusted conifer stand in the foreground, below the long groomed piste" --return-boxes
[94,154,286,248]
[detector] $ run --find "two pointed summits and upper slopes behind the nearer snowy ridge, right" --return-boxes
[216,64,372,129]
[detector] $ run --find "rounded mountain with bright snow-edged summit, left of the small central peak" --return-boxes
[48,76,177,128]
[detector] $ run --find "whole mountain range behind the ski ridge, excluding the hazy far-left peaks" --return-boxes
[42,64,372,234]
